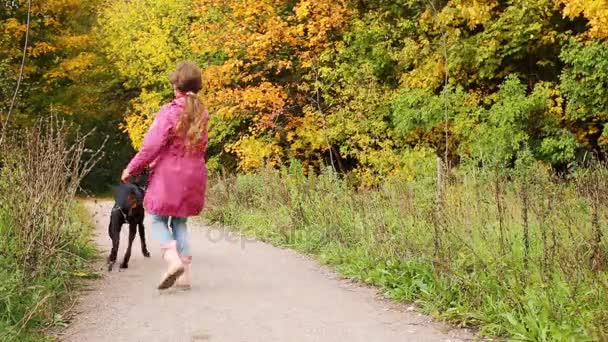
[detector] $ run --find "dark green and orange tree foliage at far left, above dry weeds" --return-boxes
[0,0,133,191]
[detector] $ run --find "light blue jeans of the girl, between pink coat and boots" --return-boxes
[150,214,191,256]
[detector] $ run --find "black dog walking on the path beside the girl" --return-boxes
[108,184,150,271]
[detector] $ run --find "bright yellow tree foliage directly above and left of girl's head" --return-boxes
[98,0,193,148]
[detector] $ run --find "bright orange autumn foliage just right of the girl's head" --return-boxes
[192,0,350,170]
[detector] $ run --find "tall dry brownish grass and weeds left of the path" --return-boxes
[0,119,99,341]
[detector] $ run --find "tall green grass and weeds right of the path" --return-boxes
[206,163,608,341]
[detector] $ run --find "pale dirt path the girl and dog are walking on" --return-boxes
[61,202,469,342]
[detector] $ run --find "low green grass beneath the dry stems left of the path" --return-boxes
[0,202,97,341]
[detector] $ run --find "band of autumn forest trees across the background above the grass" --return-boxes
[0,0,608,185]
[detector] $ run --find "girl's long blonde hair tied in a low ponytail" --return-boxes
[169,62,209,150]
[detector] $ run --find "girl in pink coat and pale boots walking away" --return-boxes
[121,62,209,290]
